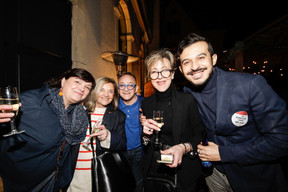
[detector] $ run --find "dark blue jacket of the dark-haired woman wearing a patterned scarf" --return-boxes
[0,86,79,192]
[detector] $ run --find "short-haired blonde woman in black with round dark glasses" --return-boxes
[141,49,204,192]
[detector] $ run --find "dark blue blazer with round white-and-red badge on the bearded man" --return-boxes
[185,67,288,192]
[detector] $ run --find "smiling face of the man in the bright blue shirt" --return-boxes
[118,75,138,105]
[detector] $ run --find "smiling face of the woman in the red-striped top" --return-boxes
[96,83,115,108]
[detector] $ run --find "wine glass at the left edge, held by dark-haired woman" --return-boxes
[0,86,25,137]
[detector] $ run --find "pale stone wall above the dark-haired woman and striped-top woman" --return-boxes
[71,0,118,79]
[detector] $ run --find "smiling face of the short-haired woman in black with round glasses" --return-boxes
[149,58,174,92]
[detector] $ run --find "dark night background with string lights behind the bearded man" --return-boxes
[160,0,288,102]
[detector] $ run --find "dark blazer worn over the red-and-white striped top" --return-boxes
[96,105,127,155]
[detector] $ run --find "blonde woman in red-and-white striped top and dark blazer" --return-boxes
[68,77,127,192]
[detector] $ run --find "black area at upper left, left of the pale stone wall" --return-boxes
[0,0,72,91]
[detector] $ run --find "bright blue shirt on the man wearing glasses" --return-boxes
[118,95,144,150]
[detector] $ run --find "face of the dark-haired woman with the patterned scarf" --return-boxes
[61,77,92,109]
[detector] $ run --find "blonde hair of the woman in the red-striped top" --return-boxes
[85,77,119,112]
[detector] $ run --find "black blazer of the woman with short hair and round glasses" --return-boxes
[141,88,205,191]
